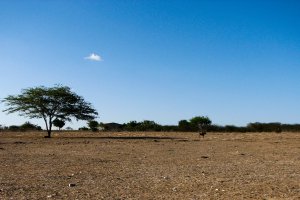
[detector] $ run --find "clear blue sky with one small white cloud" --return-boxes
[0,0,300,128]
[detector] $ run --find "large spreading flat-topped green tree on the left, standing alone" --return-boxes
[2,85,98,138]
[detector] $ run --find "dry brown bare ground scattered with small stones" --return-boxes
[0,132,300,199]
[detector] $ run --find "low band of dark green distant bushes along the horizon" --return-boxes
[0,120,300,133]
